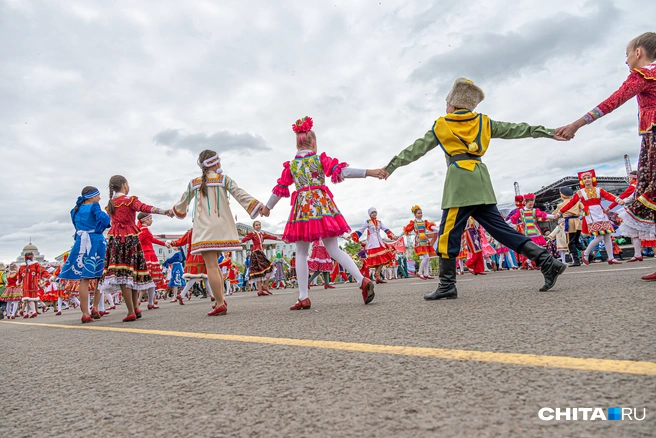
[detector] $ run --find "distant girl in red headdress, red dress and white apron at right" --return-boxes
[556,170,624,265]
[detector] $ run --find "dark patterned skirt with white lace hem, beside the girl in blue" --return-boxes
[100,234,155,292]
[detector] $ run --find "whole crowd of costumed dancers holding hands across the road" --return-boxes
[0,32,656,323]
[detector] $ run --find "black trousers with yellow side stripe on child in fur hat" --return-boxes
[437,204,531,259]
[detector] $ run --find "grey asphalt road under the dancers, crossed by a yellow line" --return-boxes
[0,259,656,438]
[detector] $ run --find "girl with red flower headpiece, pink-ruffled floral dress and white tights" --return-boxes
[263,117,381,310]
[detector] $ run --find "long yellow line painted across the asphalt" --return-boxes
[5,321,656,376]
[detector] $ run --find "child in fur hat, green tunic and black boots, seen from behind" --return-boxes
[384,78,566,300]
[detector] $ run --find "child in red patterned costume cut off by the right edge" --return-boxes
[557,32,656,281]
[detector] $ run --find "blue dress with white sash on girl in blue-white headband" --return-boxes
[59,202,111,280]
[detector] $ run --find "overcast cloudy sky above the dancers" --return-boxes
[0,0,654,262]
